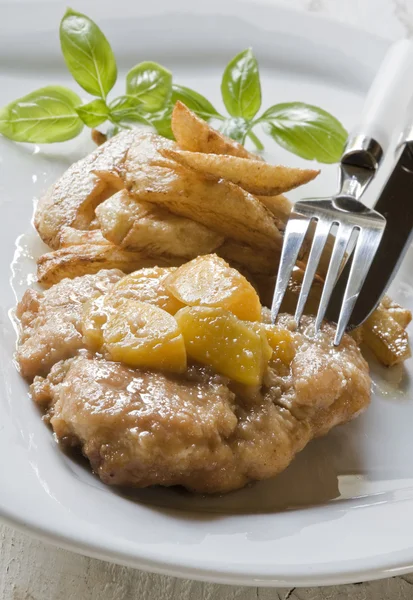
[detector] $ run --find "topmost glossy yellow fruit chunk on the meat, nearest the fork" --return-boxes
[165,254,261,321]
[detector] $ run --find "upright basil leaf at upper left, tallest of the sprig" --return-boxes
[60,9,117,99]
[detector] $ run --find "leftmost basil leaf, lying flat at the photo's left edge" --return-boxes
[0,86,83,144]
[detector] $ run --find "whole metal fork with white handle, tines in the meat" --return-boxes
[271,40,413,345]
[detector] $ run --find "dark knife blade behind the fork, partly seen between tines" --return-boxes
[326,141,413,329]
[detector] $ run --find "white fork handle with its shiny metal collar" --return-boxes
[342,40,413,169]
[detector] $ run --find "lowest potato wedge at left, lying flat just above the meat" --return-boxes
[37,244,184,286]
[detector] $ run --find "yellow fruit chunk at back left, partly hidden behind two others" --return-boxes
[108,267,184,315]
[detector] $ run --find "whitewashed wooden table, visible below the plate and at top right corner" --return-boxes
[0,0,413,600]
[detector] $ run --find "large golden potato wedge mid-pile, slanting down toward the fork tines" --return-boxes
[120,133,282,252]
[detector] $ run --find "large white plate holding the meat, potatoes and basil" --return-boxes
[0,0,413,585]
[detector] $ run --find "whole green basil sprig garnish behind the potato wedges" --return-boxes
[0,9,347,163]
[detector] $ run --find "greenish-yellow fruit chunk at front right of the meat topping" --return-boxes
[175,307,272,385]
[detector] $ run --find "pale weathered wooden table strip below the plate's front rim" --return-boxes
[0,526,413,600]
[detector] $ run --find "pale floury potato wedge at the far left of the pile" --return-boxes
[34,129,141,248]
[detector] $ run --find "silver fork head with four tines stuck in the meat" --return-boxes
[271,199,385,345]
